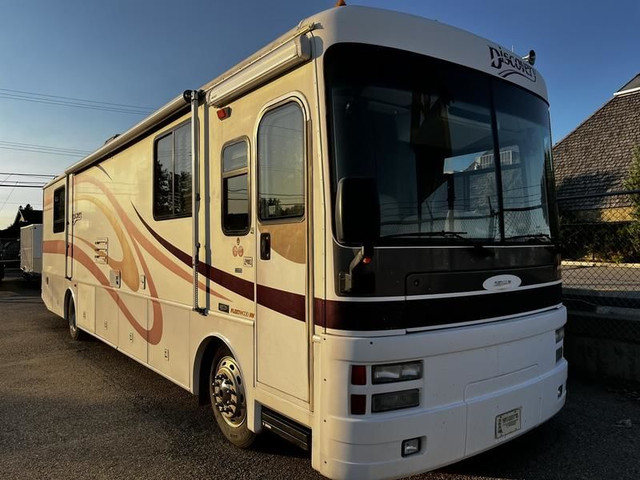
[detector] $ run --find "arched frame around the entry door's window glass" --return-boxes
[254,99,310,225]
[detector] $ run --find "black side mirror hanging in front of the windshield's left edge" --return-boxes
[335,177,380,248]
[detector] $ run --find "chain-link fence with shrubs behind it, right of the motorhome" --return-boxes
[558,190,640,343]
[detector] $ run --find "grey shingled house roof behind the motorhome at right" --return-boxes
[553,74,640,209]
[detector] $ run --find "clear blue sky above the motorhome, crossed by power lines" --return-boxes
[0,0,640,229]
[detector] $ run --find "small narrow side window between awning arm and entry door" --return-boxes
[222,140,249,235]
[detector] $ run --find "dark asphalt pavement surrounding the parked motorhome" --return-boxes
[0,272,640,480]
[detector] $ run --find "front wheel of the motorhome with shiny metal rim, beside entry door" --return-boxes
[209,347,256,448]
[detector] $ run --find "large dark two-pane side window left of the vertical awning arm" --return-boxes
[153,122,191,220]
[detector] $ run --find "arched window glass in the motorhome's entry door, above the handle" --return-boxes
[258,102,305,220]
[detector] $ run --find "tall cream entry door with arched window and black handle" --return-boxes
[256,100,309,402]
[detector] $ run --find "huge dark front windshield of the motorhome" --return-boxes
[325,44,551,244]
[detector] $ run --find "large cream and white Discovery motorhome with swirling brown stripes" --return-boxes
[42,7,567,478]
